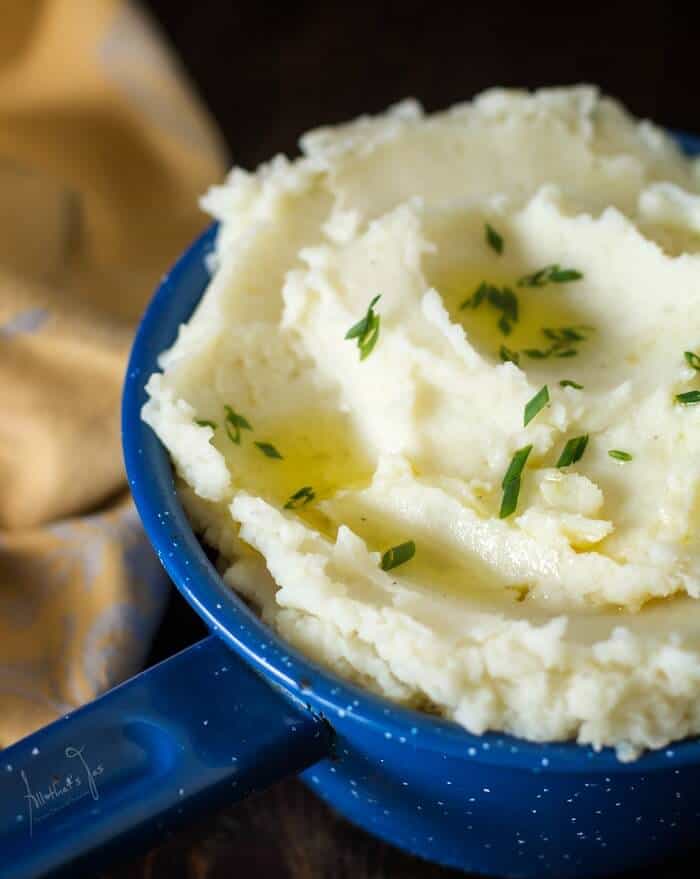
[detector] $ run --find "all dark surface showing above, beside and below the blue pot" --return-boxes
[109,0,700,879]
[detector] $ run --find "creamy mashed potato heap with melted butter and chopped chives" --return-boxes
[143,87,700,759]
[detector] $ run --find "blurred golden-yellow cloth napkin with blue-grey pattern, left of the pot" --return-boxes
[0,0,225,747]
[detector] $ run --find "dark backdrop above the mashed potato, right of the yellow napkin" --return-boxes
[146,0,700,167]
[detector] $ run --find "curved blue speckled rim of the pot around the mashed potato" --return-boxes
[122,132,700,773]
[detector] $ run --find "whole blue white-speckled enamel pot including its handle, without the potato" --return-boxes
[0,136,700,879]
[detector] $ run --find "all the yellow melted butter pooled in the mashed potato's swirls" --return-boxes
[208,264,636,629]
